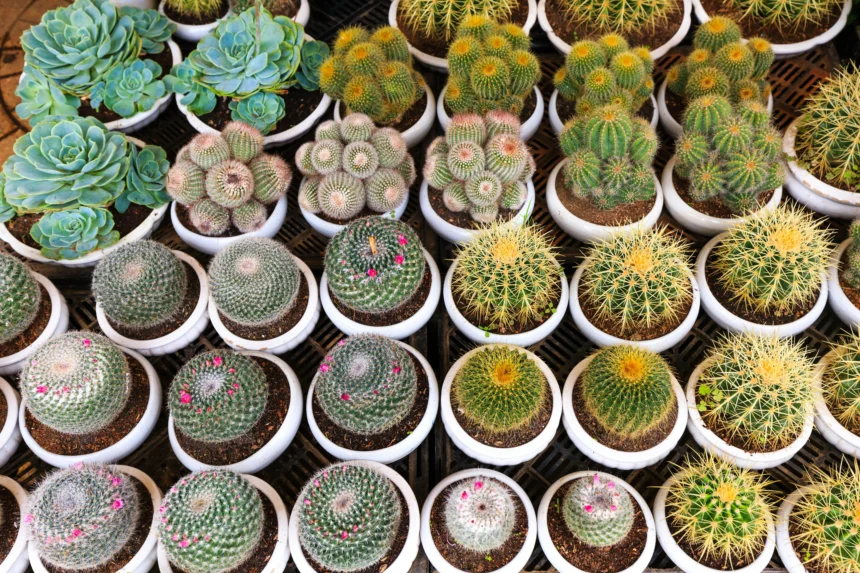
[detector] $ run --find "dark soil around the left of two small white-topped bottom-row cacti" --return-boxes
[430,482,529,573]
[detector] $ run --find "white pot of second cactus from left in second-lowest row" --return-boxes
[167,350,303,473]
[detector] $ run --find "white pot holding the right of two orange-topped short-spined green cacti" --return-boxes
[559,355,687,472]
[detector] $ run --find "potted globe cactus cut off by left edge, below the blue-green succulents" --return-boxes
[0,252,69,374]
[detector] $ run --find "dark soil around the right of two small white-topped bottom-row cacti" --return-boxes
[546,480,648,573]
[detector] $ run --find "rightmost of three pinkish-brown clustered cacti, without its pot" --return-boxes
[424,111,535,223]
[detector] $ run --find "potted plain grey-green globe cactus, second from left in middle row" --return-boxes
[92,241,209,356]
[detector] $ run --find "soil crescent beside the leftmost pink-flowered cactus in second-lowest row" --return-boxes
[24,354,149,456]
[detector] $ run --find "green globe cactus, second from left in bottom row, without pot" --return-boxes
[158,470,264,573]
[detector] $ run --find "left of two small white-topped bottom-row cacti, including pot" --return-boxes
[421,469,538,573]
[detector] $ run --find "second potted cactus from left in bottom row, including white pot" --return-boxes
[158,470,290,573]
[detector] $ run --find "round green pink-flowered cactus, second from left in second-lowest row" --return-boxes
[167,350,269,443]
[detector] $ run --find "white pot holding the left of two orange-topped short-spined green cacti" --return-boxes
[444,344,561,464]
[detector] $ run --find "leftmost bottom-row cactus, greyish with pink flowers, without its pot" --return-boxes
[24,464,141,571]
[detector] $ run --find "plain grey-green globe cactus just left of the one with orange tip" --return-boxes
[209,238,302,326]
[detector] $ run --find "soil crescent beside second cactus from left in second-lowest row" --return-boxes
[173,356,290,466]
